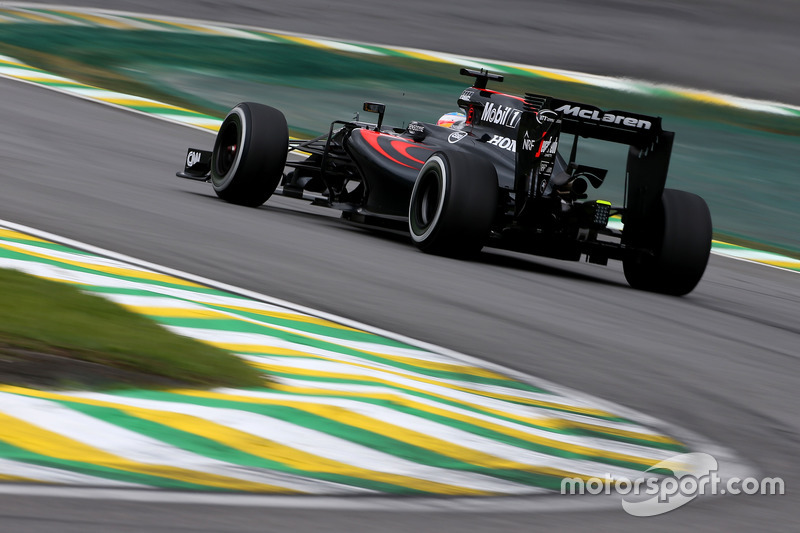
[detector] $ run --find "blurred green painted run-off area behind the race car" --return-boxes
[0,24,800,257]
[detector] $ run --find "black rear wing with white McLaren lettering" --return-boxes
[514,93,675,226]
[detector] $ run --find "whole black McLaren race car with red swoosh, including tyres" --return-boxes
[178,69,711,295]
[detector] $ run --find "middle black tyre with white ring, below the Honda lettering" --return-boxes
[408,151,497,257]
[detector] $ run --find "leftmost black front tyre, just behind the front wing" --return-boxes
[211,102,289,207]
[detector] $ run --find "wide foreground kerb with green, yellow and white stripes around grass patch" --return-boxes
[0,223,689,496]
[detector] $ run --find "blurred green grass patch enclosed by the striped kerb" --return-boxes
[0,269,264,388]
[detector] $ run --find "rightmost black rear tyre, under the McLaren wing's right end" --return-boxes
[622,189,712,296]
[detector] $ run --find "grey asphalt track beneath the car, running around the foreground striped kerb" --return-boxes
[0,2,800,533]
